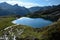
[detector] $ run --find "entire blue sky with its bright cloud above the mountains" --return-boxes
[0,0,60,8]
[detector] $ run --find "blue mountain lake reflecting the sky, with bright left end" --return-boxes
[12,17,52,28]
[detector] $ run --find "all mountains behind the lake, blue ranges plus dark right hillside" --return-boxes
[0,2,60,20]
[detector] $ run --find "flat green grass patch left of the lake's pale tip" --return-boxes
[0,16,15,30]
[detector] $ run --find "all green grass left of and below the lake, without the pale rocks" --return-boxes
[0,16,60,40]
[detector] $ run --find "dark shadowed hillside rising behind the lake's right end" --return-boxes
[27,5,60,21]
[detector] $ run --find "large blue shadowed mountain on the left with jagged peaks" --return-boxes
[0,2,29,16]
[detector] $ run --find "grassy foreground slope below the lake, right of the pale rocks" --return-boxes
[9,18,60,40]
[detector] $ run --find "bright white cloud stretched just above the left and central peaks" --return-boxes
[0,1,43,8]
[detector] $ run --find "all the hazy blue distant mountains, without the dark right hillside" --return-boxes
[0,2,55,16]
